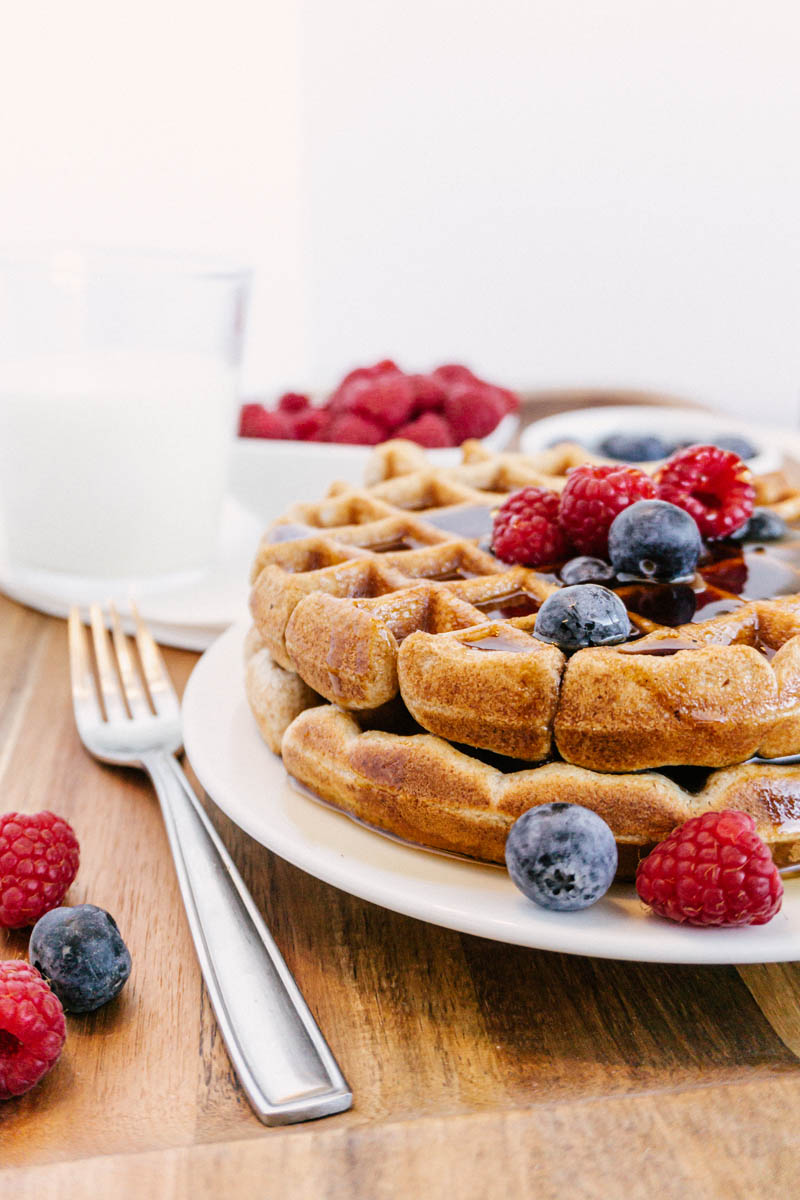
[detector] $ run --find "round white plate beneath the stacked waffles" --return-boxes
[184,623,800,962]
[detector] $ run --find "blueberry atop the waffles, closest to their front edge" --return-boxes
[534,583,631,650]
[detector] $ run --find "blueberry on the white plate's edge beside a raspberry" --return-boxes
[506,804,616,912]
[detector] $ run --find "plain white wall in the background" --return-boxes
[0,0,800,425]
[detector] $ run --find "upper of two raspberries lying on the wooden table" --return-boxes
[0,812,80,929]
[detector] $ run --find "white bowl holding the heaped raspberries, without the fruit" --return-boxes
[229,413,519,521]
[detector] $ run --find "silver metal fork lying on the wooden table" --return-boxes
[70,605,353,1124]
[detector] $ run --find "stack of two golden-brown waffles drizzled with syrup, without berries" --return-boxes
[246,442,800,862]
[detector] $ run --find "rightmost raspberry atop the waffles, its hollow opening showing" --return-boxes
[656,445,756,538]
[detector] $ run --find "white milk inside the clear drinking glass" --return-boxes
[0,355,236,578]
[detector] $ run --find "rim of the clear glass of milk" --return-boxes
[0,240,253,282]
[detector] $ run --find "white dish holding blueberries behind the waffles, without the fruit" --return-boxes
[519,404,783,474]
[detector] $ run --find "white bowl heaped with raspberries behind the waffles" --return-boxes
[230,360,518,520]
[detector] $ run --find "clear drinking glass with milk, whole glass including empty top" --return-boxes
[0,248,249,584]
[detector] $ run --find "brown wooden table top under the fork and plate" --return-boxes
[0,596,800,1200]
